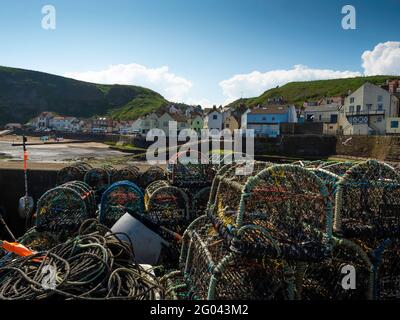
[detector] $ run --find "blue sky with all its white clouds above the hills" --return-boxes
[0,0,400,105]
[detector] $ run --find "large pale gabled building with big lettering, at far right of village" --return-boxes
[339,82,399,135]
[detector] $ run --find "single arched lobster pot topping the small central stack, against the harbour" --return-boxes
[167,151,213,188]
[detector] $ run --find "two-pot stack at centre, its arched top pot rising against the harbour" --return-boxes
[167,150,215,220]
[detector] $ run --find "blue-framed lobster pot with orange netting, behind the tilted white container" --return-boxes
[99,181,144,227]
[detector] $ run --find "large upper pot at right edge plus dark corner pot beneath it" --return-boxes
[334,160,400,299]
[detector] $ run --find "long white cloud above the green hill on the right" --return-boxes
[219,65,362,103]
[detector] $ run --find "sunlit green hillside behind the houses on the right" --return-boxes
[229,76,399,108]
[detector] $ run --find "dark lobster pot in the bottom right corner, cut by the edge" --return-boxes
[374,238,400,300]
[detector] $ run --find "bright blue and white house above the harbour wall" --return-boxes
[241,105,297,137]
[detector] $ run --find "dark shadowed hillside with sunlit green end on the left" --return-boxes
[0,66,168,125]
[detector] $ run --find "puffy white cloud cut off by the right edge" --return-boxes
[361,41,400,76]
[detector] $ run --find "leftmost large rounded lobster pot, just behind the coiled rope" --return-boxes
[36,181,96,232]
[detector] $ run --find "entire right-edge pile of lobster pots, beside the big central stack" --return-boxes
[303,160,400,299]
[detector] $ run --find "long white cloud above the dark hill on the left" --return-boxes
[64,63,192,102]
